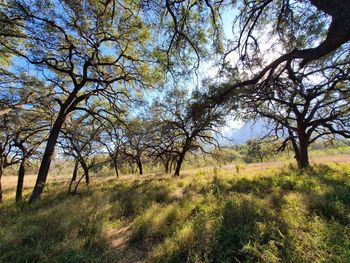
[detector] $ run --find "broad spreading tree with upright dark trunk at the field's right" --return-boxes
[238,62,350,168]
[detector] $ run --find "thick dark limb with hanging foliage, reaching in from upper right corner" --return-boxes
[159,0,350,105]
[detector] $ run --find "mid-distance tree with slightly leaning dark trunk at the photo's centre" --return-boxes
[154,89,225,176]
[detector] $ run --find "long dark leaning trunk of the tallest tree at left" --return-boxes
[29,110,65,203]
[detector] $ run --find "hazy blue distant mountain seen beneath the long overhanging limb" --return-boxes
[220,120,266,145]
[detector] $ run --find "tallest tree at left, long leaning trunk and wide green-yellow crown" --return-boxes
[0,0,161,201]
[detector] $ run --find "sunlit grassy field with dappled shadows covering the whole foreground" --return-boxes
[0,155,350,263]
